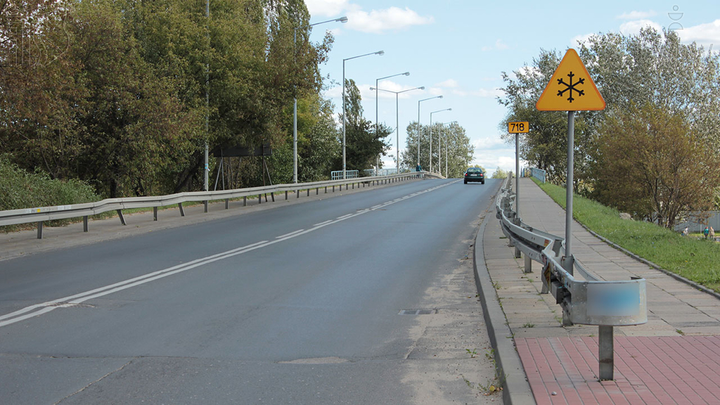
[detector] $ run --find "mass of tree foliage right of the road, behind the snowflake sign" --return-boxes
[498,28,720,219]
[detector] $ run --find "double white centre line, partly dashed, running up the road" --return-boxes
[0,182,455,328]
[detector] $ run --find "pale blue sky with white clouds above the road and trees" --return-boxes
[305,0,720,175]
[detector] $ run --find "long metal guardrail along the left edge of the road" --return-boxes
[0,172,424,239]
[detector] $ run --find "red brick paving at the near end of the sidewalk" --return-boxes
[515,336,720,405]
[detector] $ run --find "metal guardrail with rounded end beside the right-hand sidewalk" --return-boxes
[495,176,647,380]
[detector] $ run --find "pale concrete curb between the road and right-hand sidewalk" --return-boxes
[473,189,536,405]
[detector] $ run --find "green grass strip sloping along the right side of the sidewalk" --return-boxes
[533,179,720,292]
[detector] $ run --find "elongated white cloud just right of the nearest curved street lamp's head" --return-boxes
[346,7,434,34]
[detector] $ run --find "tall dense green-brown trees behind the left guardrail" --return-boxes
[0,0,337,197]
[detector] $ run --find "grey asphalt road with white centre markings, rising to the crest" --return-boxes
[0,180,500,404]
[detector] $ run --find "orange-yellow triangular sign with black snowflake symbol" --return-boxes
[535,49,605,111]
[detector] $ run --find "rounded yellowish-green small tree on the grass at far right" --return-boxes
[593,103,720,228]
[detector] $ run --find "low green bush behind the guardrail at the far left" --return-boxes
[0,155,100,232]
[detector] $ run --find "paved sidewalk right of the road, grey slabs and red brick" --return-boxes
[478,179,720,405]
